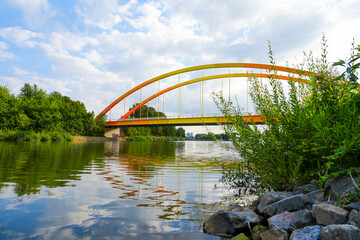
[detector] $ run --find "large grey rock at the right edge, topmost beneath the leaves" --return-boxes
[327,176,360,201]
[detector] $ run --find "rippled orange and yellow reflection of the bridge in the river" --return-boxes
[98,142,236,220]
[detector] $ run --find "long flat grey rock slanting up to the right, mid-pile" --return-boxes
[264,194,307,217]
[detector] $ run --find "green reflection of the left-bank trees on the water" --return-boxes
[0,142,104,196]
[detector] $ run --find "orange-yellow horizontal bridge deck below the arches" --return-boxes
[105,115,262,127]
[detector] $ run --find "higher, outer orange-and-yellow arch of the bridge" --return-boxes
[95,63,310,119]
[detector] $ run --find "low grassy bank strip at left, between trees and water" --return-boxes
[0,130,73,141]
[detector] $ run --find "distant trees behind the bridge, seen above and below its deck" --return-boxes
[124,103,185,139]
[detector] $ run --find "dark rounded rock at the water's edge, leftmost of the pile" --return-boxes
[204,210,235,237]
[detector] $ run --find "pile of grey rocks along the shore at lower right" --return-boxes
[203,173,360,240]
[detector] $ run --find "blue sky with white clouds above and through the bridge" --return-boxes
[0,0,360,132]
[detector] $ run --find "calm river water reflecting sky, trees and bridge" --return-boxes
[0,142,239,240]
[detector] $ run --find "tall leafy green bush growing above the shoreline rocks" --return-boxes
[214,38,360,189]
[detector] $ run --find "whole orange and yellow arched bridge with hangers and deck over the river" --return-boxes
[96,63,310,127]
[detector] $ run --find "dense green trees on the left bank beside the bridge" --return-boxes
[0,83,105,140]
